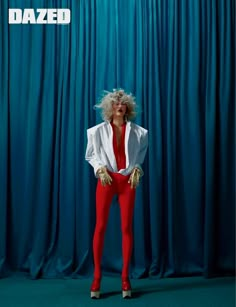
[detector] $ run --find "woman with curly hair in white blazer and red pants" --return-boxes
[85,89,148,298]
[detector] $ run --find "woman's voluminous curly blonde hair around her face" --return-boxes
[95,89,136,121]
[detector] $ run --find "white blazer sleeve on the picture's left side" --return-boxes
[85,129,104,178]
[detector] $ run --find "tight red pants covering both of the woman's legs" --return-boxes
[93,172,135,278]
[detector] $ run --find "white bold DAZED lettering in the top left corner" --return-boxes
[8,8,71,24]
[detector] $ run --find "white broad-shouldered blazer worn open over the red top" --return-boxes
[85,121,148,177]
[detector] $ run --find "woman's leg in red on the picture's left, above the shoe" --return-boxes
[93,180,115,279]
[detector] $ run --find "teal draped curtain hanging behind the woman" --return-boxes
[0,0,235,278]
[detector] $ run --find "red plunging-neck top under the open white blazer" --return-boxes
[111,122,126,171]
